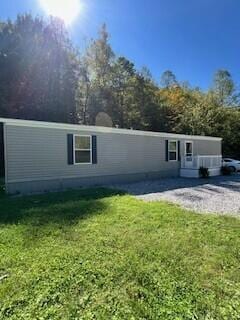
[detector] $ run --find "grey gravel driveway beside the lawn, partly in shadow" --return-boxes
[111,174,240,217]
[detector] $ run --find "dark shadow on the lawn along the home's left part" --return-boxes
[0,188,124,226]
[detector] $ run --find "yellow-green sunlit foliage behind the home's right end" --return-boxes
[158,85,240,158]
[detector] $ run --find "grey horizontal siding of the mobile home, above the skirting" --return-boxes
[5,125,221,182]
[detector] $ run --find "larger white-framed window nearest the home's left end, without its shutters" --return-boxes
[74,135,92,164]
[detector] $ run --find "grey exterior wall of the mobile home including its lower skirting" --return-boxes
[0,119,221,193]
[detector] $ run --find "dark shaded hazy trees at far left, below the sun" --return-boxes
[0,15,78,122]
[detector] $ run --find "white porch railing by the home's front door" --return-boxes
[181,156,222,169]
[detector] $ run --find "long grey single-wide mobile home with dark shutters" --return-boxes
[0,118,222,194]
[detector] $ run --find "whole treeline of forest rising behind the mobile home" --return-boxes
[0,14,240,157]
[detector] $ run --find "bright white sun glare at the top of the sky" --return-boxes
[39,0,81,24]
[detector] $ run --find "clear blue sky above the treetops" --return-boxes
[0,0,240,89]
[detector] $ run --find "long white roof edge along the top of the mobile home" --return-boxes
[0,118,222,141]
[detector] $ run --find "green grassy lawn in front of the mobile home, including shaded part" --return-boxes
[0,189,240,320]
